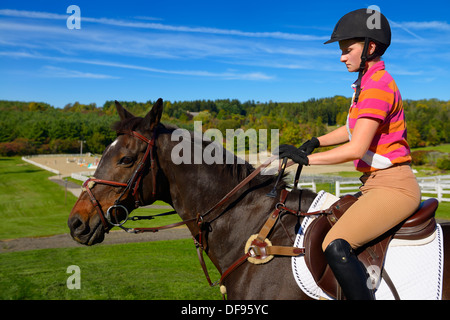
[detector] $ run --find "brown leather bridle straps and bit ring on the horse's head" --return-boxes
[83,128,156,232]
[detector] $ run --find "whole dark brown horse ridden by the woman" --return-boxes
[68,99,450,299]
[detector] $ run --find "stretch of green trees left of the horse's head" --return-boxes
[0,101,115,156]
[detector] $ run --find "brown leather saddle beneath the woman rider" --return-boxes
[304,195,438,299]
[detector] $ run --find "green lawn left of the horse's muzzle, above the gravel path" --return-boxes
[0,158,76,239]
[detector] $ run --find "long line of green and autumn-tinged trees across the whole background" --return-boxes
[0,96,450,156]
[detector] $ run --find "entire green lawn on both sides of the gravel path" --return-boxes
[0,158,450,300]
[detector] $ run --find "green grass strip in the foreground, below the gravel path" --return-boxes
[0,239,222,300]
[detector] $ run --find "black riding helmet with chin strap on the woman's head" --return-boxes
[325,8,391,102]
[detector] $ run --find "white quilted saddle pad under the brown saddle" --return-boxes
[292,191,444,300]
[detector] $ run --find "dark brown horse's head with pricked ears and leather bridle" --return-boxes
[68,99,170,245]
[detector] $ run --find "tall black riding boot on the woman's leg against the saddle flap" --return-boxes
[325,239,375,300]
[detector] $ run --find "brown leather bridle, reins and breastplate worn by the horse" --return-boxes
[83,129,328,297]
